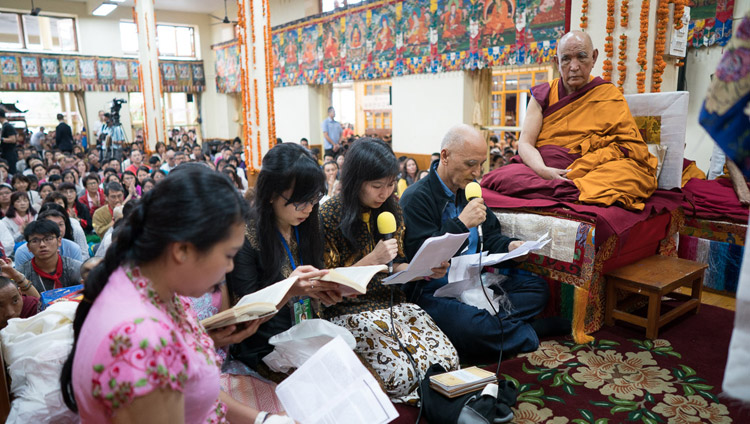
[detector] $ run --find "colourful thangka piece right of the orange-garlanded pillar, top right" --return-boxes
[688,0,734,47]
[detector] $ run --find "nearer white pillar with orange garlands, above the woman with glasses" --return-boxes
[238,0,276,176]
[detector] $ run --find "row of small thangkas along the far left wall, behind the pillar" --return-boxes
[0,52,205,93]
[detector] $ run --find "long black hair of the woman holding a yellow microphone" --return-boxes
[339,137,401,249]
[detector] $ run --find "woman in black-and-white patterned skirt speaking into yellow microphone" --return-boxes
[320,138,458,402]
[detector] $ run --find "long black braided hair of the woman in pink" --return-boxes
[60,166,248,412]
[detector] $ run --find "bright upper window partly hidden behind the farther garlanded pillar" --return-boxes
[120,22,196,57]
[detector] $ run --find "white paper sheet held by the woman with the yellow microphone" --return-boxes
[383,233,469,285]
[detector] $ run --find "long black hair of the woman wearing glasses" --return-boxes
[251,143,325,286]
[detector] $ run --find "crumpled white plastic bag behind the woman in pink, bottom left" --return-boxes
[0,302,80,424]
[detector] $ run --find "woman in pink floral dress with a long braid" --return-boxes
[61,165,284,423]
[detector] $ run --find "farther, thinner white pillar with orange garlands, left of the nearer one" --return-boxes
[133,0,167,152]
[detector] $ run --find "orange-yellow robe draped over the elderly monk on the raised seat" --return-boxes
[536,78,658,210]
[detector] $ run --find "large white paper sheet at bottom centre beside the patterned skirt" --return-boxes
[276,337,398,424]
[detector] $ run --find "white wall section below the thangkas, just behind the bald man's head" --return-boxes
[391,71,473,154]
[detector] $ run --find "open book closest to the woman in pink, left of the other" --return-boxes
[201,277,298,330]
